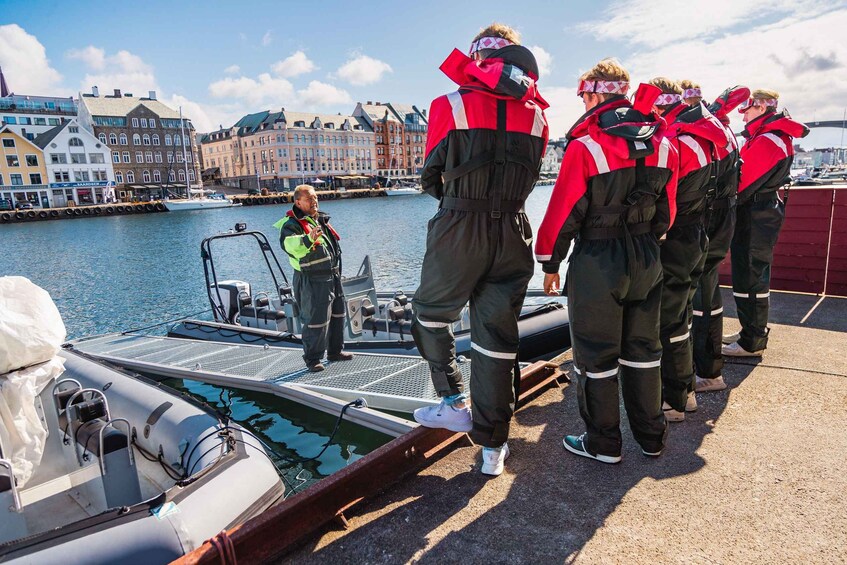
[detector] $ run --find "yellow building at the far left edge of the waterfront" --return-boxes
[0,125,49,208]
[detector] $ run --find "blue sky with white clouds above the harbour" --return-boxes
[0,0,847,148]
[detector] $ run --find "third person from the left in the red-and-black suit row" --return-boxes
[650,77,728,422]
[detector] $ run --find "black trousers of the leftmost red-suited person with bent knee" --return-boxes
[412,209,534,447]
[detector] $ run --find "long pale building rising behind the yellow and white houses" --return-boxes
[0,69,77,141]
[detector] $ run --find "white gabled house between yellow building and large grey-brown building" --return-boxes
[34,118,115,207]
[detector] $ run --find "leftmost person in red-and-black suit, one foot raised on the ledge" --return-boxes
[412,24,548,475]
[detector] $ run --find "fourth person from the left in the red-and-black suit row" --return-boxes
[692,85,750,392]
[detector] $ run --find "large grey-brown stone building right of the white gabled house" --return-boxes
[79,87,201,201]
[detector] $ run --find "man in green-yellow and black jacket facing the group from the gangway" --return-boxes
[274,184,353,372]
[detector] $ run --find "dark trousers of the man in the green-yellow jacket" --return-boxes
[294,271,347,364]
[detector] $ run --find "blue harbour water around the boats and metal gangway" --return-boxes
[0,186,552,486]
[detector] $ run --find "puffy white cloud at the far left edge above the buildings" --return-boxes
[0,24,63,96]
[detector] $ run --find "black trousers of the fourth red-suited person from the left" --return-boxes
[691,197,735,379]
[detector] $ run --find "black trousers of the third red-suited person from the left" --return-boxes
[660,220,708,412]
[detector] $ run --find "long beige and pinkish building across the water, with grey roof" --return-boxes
[201,108,374,190]
